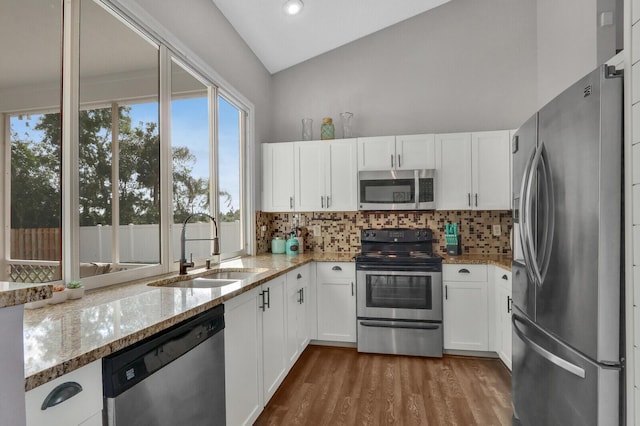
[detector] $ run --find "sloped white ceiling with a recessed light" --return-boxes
[212,0,449,74]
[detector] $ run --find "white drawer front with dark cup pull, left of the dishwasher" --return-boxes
[25,360,102,426]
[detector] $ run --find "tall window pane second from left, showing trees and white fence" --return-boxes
[78,0,160,278]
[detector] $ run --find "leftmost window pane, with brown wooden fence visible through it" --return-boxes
[0,0,62,282]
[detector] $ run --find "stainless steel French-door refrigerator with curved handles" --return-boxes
[512,66,624,426]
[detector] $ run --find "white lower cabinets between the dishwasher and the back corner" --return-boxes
[224,265,313,425]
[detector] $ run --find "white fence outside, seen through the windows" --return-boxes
[80,221,241,264]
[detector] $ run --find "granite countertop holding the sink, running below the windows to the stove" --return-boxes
[24,253,355,391]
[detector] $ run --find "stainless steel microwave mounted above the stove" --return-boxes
[358,170,436,210]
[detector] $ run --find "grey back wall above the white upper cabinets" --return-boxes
[262,0,537,142]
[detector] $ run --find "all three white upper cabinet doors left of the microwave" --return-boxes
[262,139,358,212]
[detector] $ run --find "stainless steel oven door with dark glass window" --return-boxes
[356,269,442,321]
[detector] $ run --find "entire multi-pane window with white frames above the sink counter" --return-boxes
[0,0,252,288]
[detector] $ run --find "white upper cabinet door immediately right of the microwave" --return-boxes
[435,133,472,210]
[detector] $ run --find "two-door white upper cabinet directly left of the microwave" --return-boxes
[294,139,358,211]
